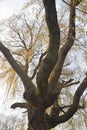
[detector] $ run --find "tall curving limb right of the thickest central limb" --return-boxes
[49,0,76,88]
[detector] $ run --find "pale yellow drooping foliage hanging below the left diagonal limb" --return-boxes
[0,61,18,96]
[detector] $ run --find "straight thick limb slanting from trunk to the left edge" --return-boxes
[0,42,35,93]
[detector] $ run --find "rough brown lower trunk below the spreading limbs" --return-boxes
[27,104,49,130]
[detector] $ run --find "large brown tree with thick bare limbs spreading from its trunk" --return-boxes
[0,0,87,130]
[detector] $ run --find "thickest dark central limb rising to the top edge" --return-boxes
[36,0,60,93]
